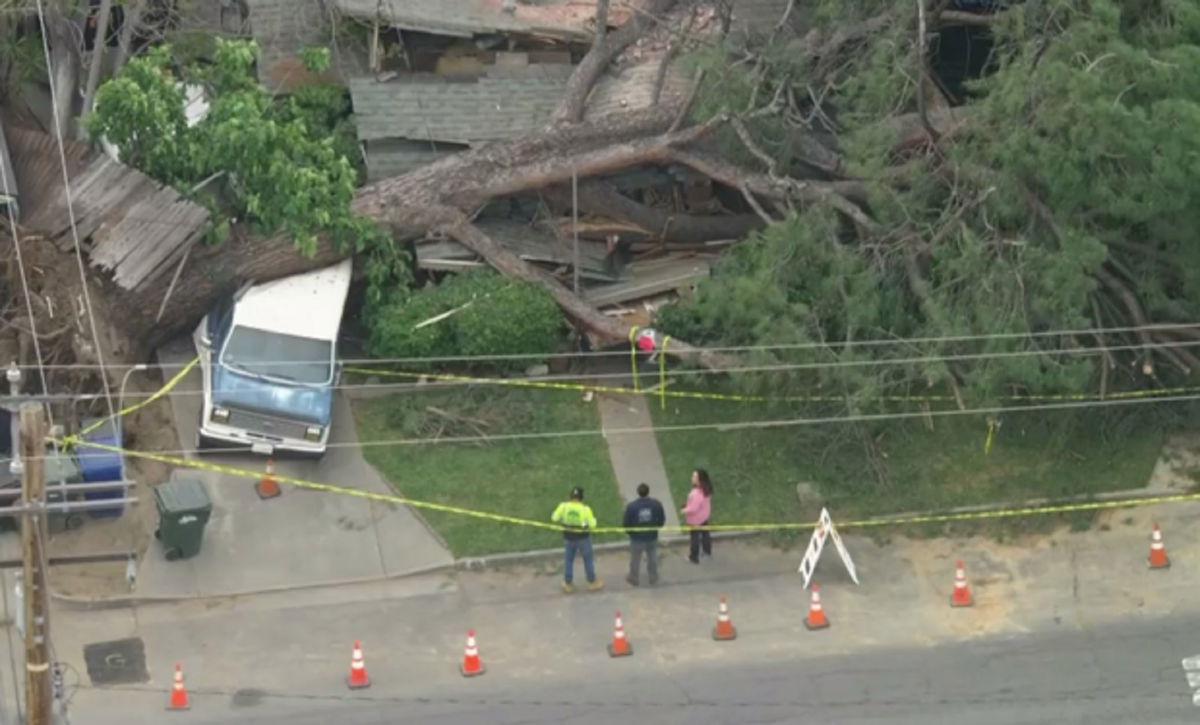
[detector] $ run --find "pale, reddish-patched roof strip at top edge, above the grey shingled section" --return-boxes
[336,0,590,41]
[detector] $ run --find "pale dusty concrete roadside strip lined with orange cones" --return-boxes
[30,503,1200,717]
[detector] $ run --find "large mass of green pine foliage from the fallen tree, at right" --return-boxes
[659,0,1200,408]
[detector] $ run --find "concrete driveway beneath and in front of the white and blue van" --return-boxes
[130,338,454,598]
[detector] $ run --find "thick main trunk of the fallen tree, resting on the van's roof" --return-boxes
[82,109,709,356]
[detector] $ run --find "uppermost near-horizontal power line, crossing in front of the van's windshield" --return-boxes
[4,323,1200,370]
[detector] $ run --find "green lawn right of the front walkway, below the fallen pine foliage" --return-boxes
[649,384,1163,541]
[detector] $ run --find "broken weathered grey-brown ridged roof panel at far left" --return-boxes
[10,128,209,289]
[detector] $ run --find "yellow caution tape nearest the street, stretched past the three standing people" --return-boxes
[60,432,1200,534]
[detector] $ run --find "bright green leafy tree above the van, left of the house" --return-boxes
[88,40,382,252]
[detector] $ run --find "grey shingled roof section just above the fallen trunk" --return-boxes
[350,66,570,145]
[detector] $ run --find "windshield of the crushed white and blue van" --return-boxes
[221,325,334,385]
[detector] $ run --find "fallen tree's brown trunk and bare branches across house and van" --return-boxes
[4,0,883,374]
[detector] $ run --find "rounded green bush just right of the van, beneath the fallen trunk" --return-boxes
[367,270,563,367]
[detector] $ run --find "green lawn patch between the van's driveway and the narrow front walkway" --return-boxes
[353,387,624,557]
